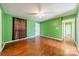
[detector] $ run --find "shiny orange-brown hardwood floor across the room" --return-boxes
[1,37,78,56]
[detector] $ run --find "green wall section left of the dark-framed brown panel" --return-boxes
[2,12,13,42]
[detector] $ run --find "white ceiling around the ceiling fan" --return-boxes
[1,3,77,22]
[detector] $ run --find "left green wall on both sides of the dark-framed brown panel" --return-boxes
[0,5,36,45]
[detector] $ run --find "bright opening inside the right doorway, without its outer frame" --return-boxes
[63,22,75,45]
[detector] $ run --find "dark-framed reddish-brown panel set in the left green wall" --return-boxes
[13,17,27,40]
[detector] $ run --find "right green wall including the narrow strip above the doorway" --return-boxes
[40,14,76,40]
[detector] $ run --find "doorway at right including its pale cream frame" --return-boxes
[62,19,75,45]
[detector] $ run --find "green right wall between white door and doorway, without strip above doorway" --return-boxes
[40,18,62,38]
